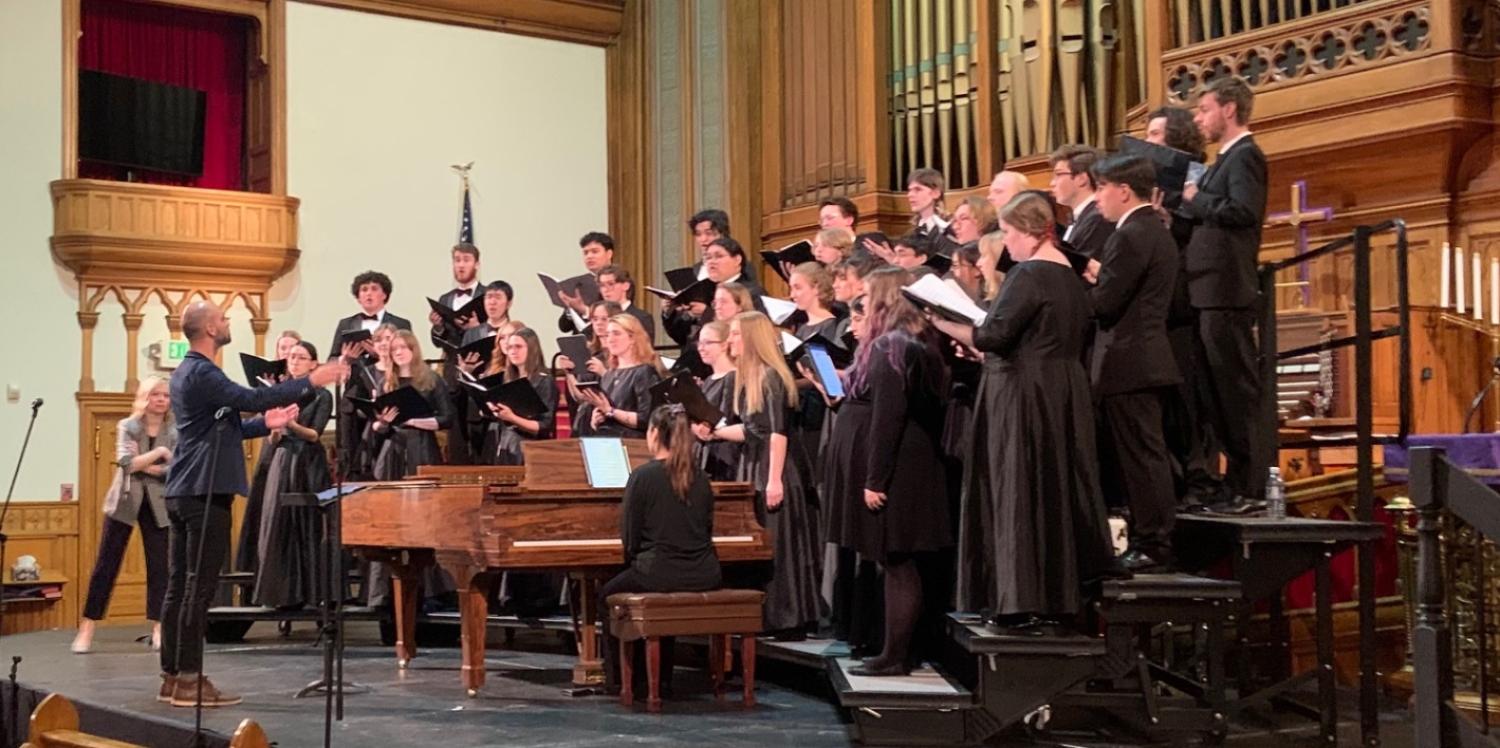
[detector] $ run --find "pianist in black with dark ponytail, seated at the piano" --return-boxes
[599,405,720,694]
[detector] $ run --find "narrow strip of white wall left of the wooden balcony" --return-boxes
[0,0,71,501]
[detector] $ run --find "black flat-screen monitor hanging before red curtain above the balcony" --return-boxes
[78,70,207,175]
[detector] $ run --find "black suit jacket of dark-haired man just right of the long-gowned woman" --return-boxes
[1089,207,1182,396]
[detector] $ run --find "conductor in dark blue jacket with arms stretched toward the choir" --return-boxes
[158,301,348,706]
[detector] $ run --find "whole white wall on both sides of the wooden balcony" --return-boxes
[0,0,608,501]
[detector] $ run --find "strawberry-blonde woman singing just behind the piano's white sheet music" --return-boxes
[576,315,666,439]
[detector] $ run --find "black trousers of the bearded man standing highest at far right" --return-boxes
[1199,309,1262,498]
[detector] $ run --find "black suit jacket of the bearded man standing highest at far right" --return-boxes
[1178,135,1266,309]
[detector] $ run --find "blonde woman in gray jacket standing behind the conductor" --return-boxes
[72,376,177,654]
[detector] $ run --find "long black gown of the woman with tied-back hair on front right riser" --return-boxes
[959,261,1112,615]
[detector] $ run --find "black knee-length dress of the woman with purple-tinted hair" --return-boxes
[845,331,953,562]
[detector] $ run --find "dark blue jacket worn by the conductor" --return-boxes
[167,351,312,498]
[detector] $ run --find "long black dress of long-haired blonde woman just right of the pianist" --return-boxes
[737,372,822,631]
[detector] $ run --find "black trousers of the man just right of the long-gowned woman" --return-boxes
[1095,388,1178,561]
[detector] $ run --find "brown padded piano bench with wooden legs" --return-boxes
[608,589,765,712]
